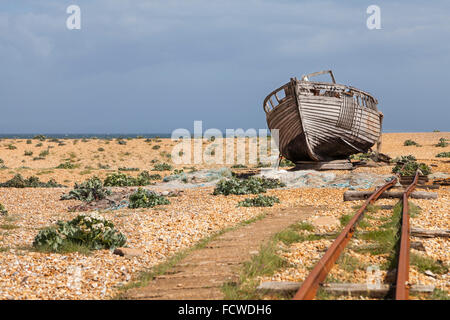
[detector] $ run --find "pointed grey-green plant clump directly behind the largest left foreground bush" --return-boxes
[61,176,111,202]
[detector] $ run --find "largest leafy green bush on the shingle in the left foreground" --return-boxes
[33,213,126,252]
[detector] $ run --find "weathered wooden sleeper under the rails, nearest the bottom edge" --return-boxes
[256,281,434,298]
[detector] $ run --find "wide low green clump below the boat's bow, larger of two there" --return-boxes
[213,177,286,196]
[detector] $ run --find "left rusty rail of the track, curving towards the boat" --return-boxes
[294,178,397,300]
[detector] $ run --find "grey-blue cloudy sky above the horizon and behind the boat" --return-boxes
[0,0,450,133]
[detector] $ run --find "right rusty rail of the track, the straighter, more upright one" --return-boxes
[395,172,419,300]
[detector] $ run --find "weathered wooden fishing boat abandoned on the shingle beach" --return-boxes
[264,70,383,162]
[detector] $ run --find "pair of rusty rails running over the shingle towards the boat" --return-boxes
[294,172,419,300]
